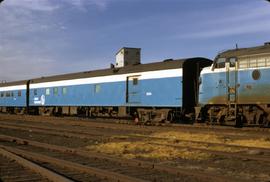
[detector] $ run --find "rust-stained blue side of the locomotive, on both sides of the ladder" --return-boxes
[199,68,270,105]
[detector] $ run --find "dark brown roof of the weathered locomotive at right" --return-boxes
[218,43,270,57]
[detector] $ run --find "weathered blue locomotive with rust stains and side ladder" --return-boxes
[199,42,270,126]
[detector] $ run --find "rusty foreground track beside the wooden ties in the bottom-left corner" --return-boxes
[0,136,238,182]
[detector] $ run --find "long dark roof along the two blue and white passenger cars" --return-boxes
[0,57,212,87]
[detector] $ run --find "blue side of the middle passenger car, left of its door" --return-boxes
[30,82,126,106]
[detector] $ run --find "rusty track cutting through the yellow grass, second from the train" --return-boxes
[0,121,270,163]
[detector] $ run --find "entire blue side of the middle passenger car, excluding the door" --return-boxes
[30,77,182,107]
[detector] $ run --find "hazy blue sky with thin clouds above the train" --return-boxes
[0,0,270,81]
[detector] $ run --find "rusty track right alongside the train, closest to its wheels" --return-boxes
[0,114,270,135]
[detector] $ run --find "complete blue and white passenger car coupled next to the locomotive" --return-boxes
[29,54,211,120]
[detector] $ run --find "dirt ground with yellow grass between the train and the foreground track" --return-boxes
[0,115,270,181]
